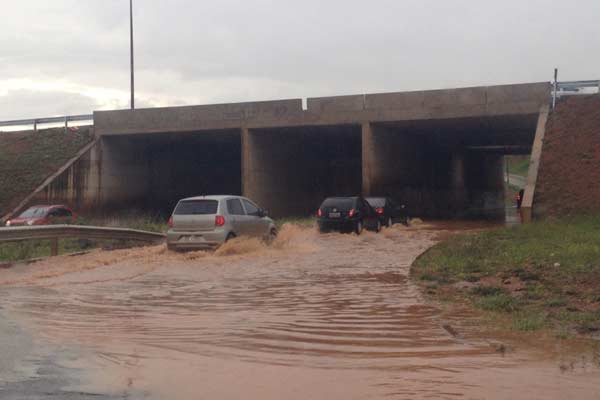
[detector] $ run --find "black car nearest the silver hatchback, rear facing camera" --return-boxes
[317,197,381,235]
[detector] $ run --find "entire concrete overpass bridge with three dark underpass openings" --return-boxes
[19,82,551,217]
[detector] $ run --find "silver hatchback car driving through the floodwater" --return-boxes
[167,196,277,250]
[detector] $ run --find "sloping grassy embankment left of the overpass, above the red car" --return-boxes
[0,127,92,216]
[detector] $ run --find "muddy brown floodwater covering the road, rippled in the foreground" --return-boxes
[0,225,600,400]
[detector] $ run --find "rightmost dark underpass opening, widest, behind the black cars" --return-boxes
[363,114,537,218]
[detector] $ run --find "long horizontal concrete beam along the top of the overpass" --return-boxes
[94,82,550,135]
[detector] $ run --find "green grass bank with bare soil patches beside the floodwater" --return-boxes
[412,216,600,337]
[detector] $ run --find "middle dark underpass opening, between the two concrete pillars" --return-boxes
[244,125,362,217]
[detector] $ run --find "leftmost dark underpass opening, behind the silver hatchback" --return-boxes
[101,129,242,215]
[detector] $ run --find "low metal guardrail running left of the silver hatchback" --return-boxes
[0,225,166,255]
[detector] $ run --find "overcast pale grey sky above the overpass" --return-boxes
[0,0,600,119]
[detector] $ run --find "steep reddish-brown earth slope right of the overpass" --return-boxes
[534,95,600,216]
